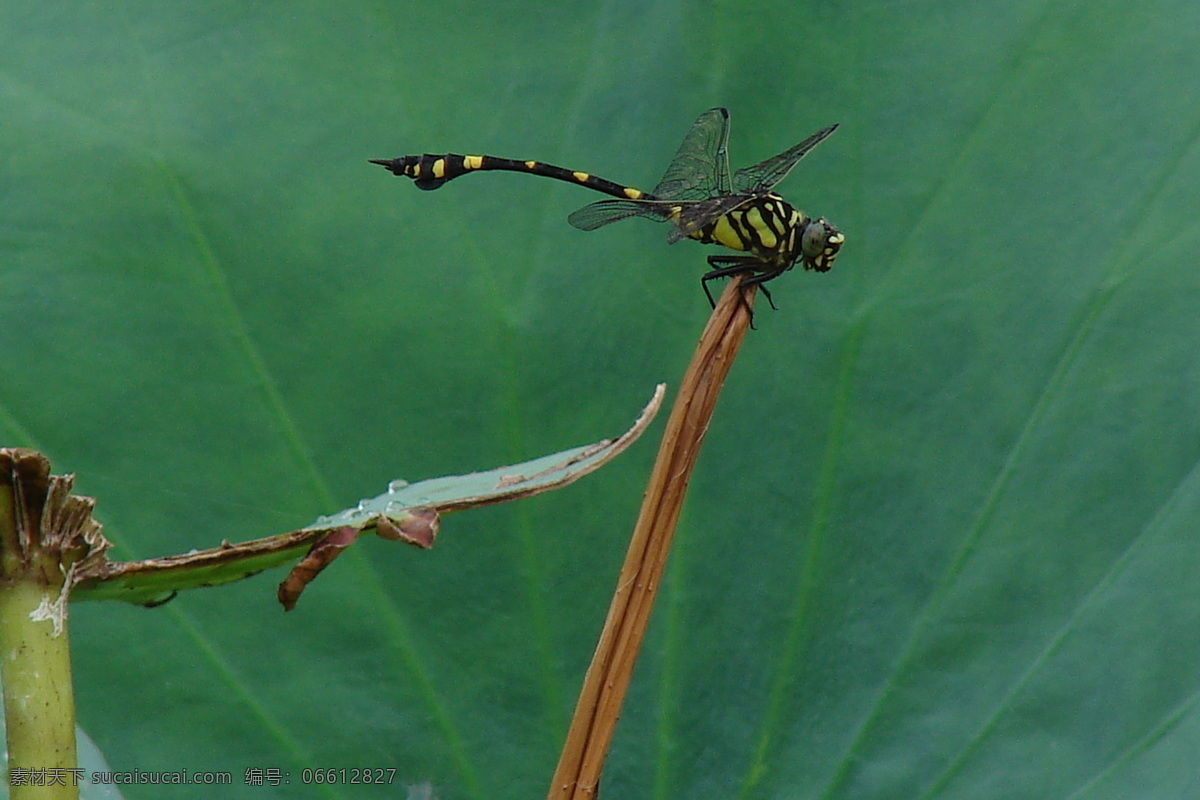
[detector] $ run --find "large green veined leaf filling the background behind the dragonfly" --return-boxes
[0,0,1200,800]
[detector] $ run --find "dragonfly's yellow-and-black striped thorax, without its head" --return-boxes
[690,193,805,266]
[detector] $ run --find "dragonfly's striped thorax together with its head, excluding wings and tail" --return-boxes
[689,192,842,272]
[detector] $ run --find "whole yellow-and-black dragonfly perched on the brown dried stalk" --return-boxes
[371,108,846,308]
